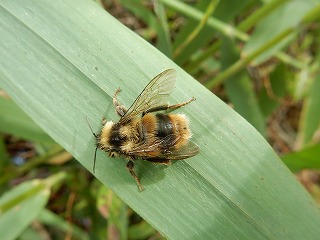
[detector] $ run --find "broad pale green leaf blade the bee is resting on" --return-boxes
[0,0,320,239]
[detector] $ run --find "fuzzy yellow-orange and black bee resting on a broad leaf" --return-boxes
[93,69,199,191]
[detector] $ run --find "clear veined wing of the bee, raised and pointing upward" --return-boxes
[120,69,177,123]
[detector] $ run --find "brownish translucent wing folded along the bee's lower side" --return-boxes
[129,135,199,161]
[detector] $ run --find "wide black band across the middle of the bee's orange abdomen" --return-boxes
[156,113,175,149]
